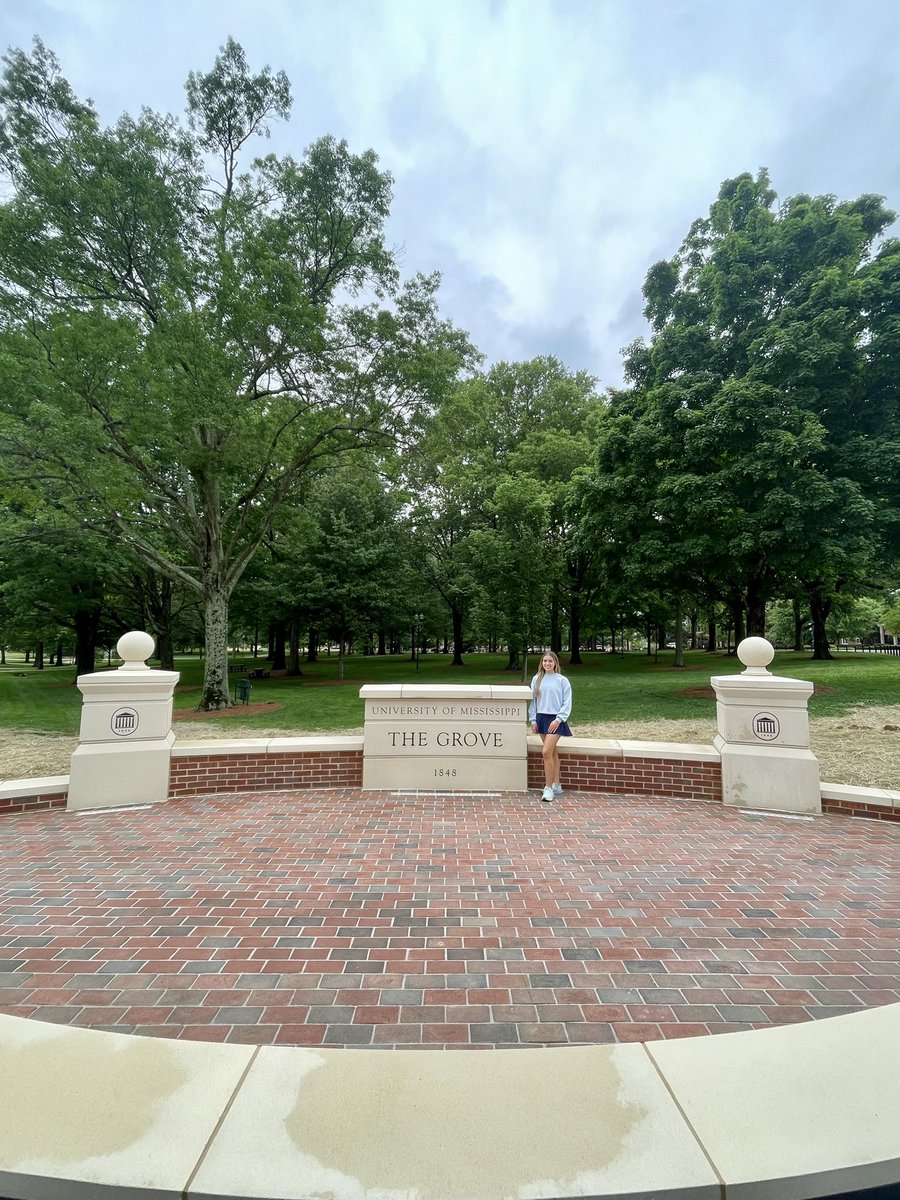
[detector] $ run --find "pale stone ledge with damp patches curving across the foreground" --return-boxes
[0,1004,900,1200]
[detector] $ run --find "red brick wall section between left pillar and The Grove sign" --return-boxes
[169,750,362,797]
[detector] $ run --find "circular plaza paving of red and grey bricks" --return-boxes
[0,788,900,1049]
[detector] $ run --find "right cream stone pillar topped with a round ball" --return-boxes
[710,637,822,812]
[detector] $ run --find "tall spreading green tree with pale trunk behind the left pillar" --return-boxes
[0,41,468,709]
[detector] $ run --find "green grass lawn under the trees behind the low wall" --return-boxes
[0,650,900,734]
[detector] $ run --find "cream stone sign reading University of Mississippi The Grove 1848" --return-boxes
[360,684,532,792]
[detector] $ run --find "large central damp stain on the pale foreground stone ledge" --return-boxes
[284,1048,646,1200]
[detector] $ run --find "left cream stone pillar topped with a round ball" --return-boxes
[66,630,179,811]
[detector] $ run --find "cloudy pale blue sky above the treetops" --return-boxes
[0,0,900,384]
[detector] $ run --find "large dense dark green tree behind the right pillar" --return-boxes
[585,172,900,658]
